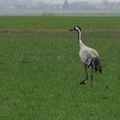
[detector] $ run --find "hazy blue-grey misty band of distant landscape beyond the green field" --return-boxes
[0,0,120,16]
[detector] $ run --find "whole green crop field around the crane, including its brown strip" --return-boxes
[0,16,120,120]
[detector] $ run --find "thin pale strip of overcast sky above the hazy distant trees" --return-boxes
[40,0,120,4]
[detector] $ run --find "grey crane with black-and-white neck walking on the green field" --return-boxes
[70,26,102,87]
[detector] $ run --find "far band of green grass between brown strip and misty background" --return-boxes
[0,16,120,29]
